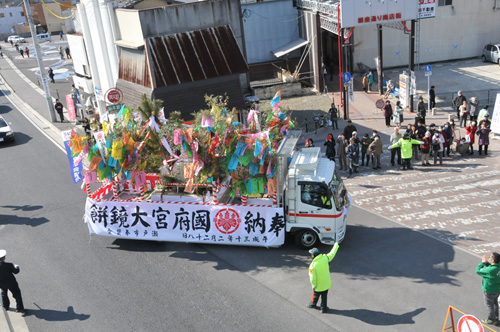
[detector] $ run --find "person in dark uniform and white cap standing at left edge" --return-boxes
[0,249,24,312]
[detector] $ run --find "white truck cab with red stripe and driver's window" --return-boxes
[283,147,350,249]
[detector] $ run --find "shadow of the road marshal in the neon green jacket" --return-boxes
[329,308,425,326]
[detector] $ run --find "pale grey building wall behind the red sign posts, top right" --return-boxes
[354,0,500,68]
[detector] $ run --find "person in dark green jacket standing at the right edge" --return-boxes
[476,252,500,325]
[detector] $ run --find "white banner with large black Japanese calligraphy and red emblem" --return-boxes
[85,198,285,247]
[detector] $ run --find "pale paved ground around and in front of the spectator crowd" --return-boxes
[261,59,500,257]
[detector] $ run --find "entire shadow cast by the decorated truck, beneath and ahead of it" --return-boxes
[112,219,460,286]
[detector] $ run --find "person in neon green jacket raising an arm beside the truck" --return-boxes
[309,242,339,314]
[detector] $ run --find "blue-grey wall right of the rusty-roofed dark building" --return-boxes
[241,0,300,64]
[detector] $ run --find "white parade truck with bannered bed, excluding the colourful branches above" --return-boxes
[84,132,351,249]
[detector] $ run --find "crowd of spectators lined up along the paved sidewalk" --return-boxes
[306,101,491,175]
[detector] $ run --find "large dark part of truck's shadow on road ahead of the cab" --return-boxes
[340,225,461,286]
